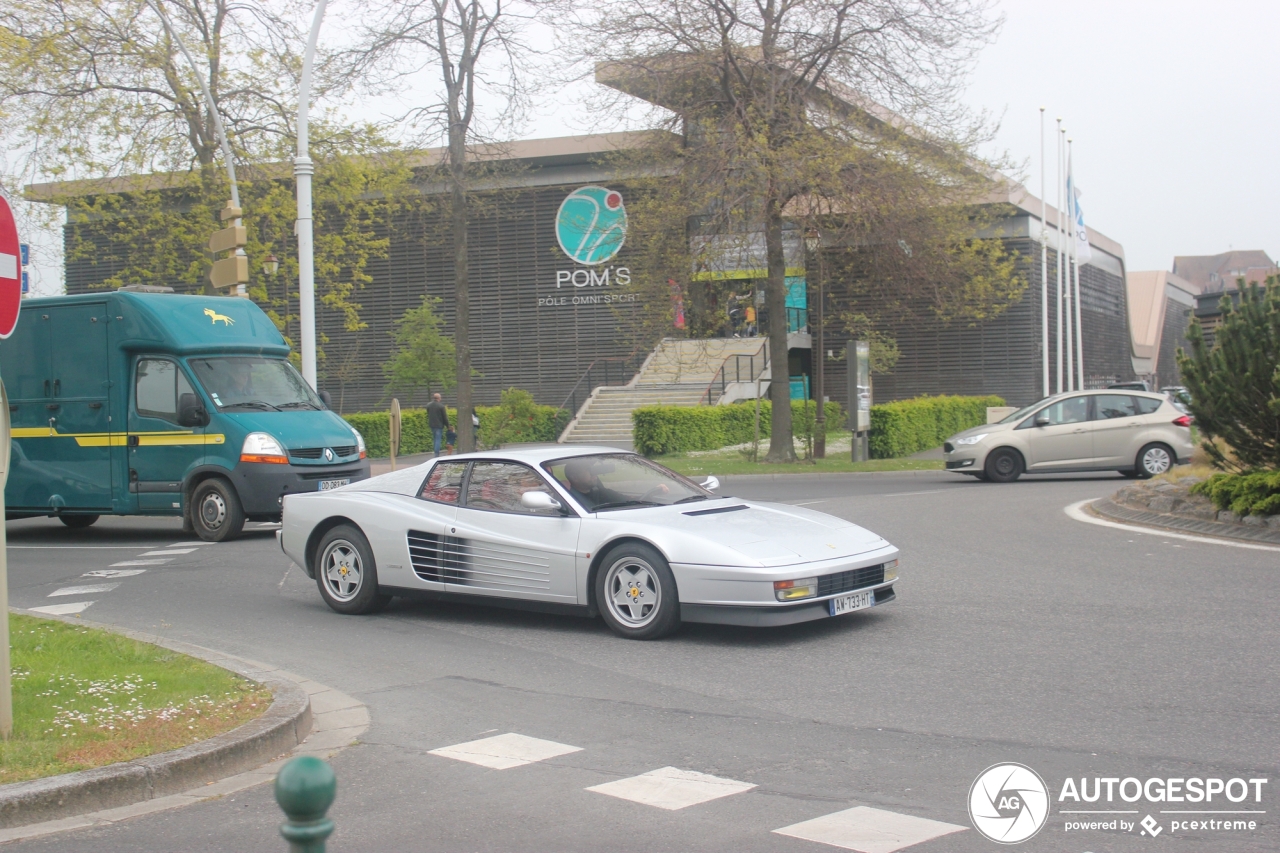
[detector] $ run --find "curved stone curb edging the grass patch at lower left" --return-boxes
[0,613,369,844]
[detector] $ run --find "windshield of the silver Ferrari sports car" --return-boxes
[543,453,716,512]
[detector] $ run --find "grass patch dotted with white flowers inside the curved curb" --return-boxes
[0,613,271,784]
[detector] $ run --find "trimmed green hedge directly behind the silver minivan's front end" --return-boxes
[868,394,1005,459]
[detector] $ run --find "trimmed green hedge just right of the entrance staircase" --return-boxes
[631,400,845,456]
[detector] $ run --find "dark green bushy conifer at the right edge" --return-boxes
[1178,275,1280,471]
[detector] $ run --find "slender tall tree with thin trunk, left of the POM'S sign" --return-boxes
[351,0,538,452]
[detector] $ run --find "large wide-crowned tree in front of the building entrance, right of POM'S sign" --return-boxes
[564,0,997,462]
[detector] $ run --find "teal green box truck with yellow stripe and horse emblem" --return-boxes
[0,288,369,542]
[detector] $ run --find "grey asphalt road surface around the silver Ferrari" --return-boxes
[8,473,1280,853]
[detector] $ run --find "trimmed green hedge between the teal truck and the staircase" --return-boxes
[343,394,570,457]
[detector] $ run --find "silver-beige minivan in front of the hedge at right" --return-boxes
[942,388,1193,483]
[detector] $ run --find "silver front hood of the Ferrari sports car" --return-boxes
[609,498,890,566]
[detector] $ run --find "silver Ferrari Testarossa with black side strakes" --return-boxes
[276,446,897,639]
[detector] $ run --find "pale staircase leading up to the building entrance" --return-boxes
[559,338,764,450]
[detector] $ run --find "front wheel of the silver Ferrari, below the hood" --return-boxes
[595,542,680,639]
